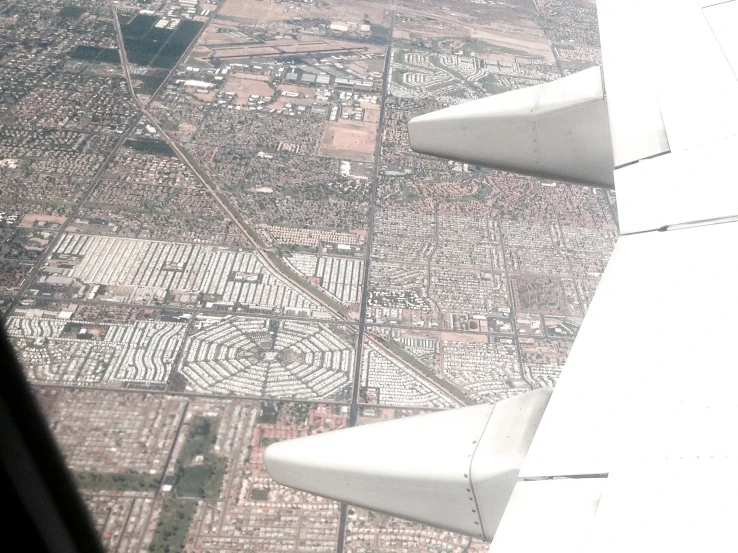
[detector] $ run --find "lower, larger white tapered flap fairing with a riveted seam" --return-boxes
[264,388,552,539]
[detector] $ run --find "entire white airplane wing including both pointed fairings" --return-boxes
[266,0,738,553]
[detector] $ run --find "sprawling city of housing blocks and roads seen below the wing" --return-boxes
[0,0,604,553]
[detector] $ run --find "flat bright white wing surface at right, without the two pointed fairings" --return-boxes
[490,0,738,553]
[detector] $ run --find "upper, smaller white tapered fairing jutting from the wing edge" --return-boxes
[408,67,615,188]
